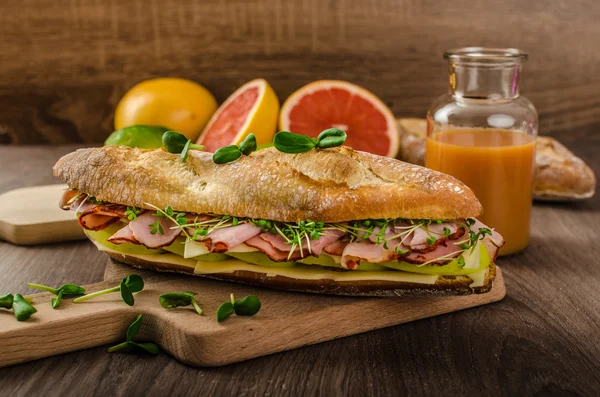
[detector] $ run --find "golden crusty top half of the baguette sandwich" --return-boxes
[54,146,481,222]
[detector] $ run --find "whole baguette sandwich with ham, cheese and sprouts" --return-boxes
[54,146,504,296]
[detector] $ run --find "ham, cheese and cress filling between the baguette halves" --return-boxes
[61,190,504,282]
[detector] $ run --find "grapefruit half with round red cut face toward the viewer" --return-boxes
[279,80,400,157]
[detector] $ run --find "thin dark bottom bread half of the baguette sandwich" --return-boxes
[106,252,496,296]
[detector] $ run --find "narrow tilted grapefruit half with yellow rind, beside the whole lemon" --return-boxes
[196,79,279,152]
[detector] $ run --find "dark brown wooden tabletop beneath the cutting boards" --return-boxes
[0,135,600,396]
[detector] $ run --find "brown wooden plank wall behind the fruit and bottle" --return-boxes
[0,0,600,144]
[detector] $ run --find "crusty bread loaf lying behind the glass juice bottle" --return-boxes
[398,118,596,201]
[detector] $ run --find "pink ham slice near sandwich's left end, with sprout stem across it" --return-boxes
[124,211,181,248]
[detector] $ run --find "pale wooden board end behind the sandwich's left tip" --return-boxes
[0,185,85,245]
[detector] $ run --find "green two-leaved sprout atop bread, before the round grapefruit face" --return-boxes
[273,128,348,154]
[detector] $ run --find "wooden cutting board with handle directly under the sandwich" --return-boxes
[0,261,506,367]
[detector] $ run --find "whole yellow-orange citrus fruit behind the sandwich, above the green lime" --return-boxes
[115,77,217,141]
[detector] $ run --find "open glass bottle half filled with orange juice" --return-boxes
[425,47,538,255]
